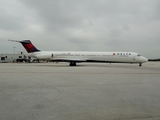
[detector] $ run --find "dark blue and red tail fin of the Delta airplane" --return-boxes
[10,40,40,53]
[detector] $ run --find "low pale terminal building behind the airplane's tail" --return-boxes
[0,52,31,63]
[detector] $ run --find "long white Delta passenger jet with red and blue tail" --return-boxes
[9,40,148,66]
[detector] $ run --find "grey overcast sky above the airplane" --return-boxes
[0,0,160,58]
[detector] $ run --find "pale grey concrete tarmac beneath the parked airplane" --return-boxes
[0,62,160,120]
